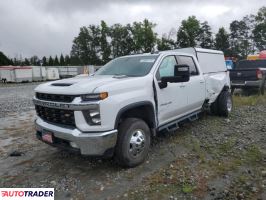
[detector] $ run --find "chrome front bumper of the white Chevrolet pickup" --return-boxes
[35,117,117,156]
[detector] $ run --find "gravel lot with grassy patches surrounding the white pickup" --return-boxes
[0,84,266,199]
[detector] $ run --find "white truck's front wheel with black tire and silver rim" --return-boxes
[115,118,151,167]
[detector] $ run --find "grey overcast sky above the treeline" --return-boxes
[0,0,266,58]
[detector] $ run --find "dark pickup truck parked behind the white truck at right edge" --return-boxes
[230,60,266,95]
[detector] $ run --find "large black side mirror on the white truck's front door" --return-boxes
[159,65,190,89]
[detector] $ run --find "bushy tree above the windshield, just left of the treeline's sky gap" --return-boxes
[132,19,157,53]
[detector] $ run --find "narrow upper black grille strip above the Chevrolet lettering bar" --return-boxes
[36,92,77,103]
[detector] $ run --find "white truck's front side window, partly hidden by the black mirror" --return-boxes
[156,56,177,80]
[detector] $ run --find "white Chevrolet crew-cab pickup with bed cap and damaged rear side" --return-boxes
[33,48,232,167]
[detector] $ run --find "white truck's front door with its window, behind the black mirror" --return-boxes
[155,55,188,125]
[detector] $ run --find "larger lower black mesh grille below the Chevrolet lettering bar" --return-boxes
[35,105,75,127]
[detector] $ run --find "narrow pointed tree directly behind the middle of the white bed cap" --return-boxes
[198,21,214,49]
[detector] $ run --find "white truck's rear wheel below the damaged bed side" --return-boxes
[218,91,233,117]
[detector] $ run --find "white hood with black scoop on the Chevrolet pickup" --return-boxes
[35,75,138,95]
